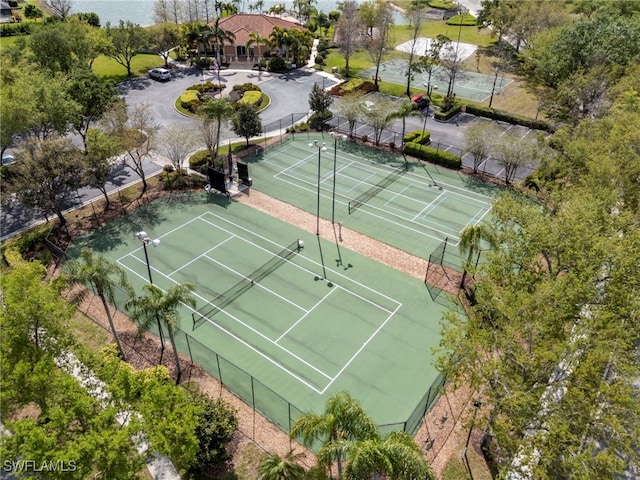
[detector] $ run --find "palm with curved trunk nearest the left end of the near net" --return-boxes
[125,283,196,384]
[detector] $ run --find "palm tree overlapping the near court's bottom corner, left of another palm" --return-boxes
[289,392,378,476]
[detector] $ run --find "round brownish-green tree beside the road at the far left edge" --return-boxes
[6,138,83,226]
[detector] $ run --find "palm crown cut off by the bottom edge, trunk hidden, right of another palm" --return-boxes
[334,432,435,480]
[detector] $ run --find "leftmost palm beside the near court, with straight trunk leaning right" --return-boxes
[65,248,133,360]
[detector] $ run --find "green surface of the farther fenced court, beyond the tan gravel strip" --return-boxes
[247,134,498,264]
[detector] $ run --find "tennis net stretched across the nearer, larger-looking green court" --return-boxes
[191,239,302,328]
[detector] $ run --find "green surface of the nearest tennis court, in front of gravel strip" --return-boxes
[72,195,445,430]
